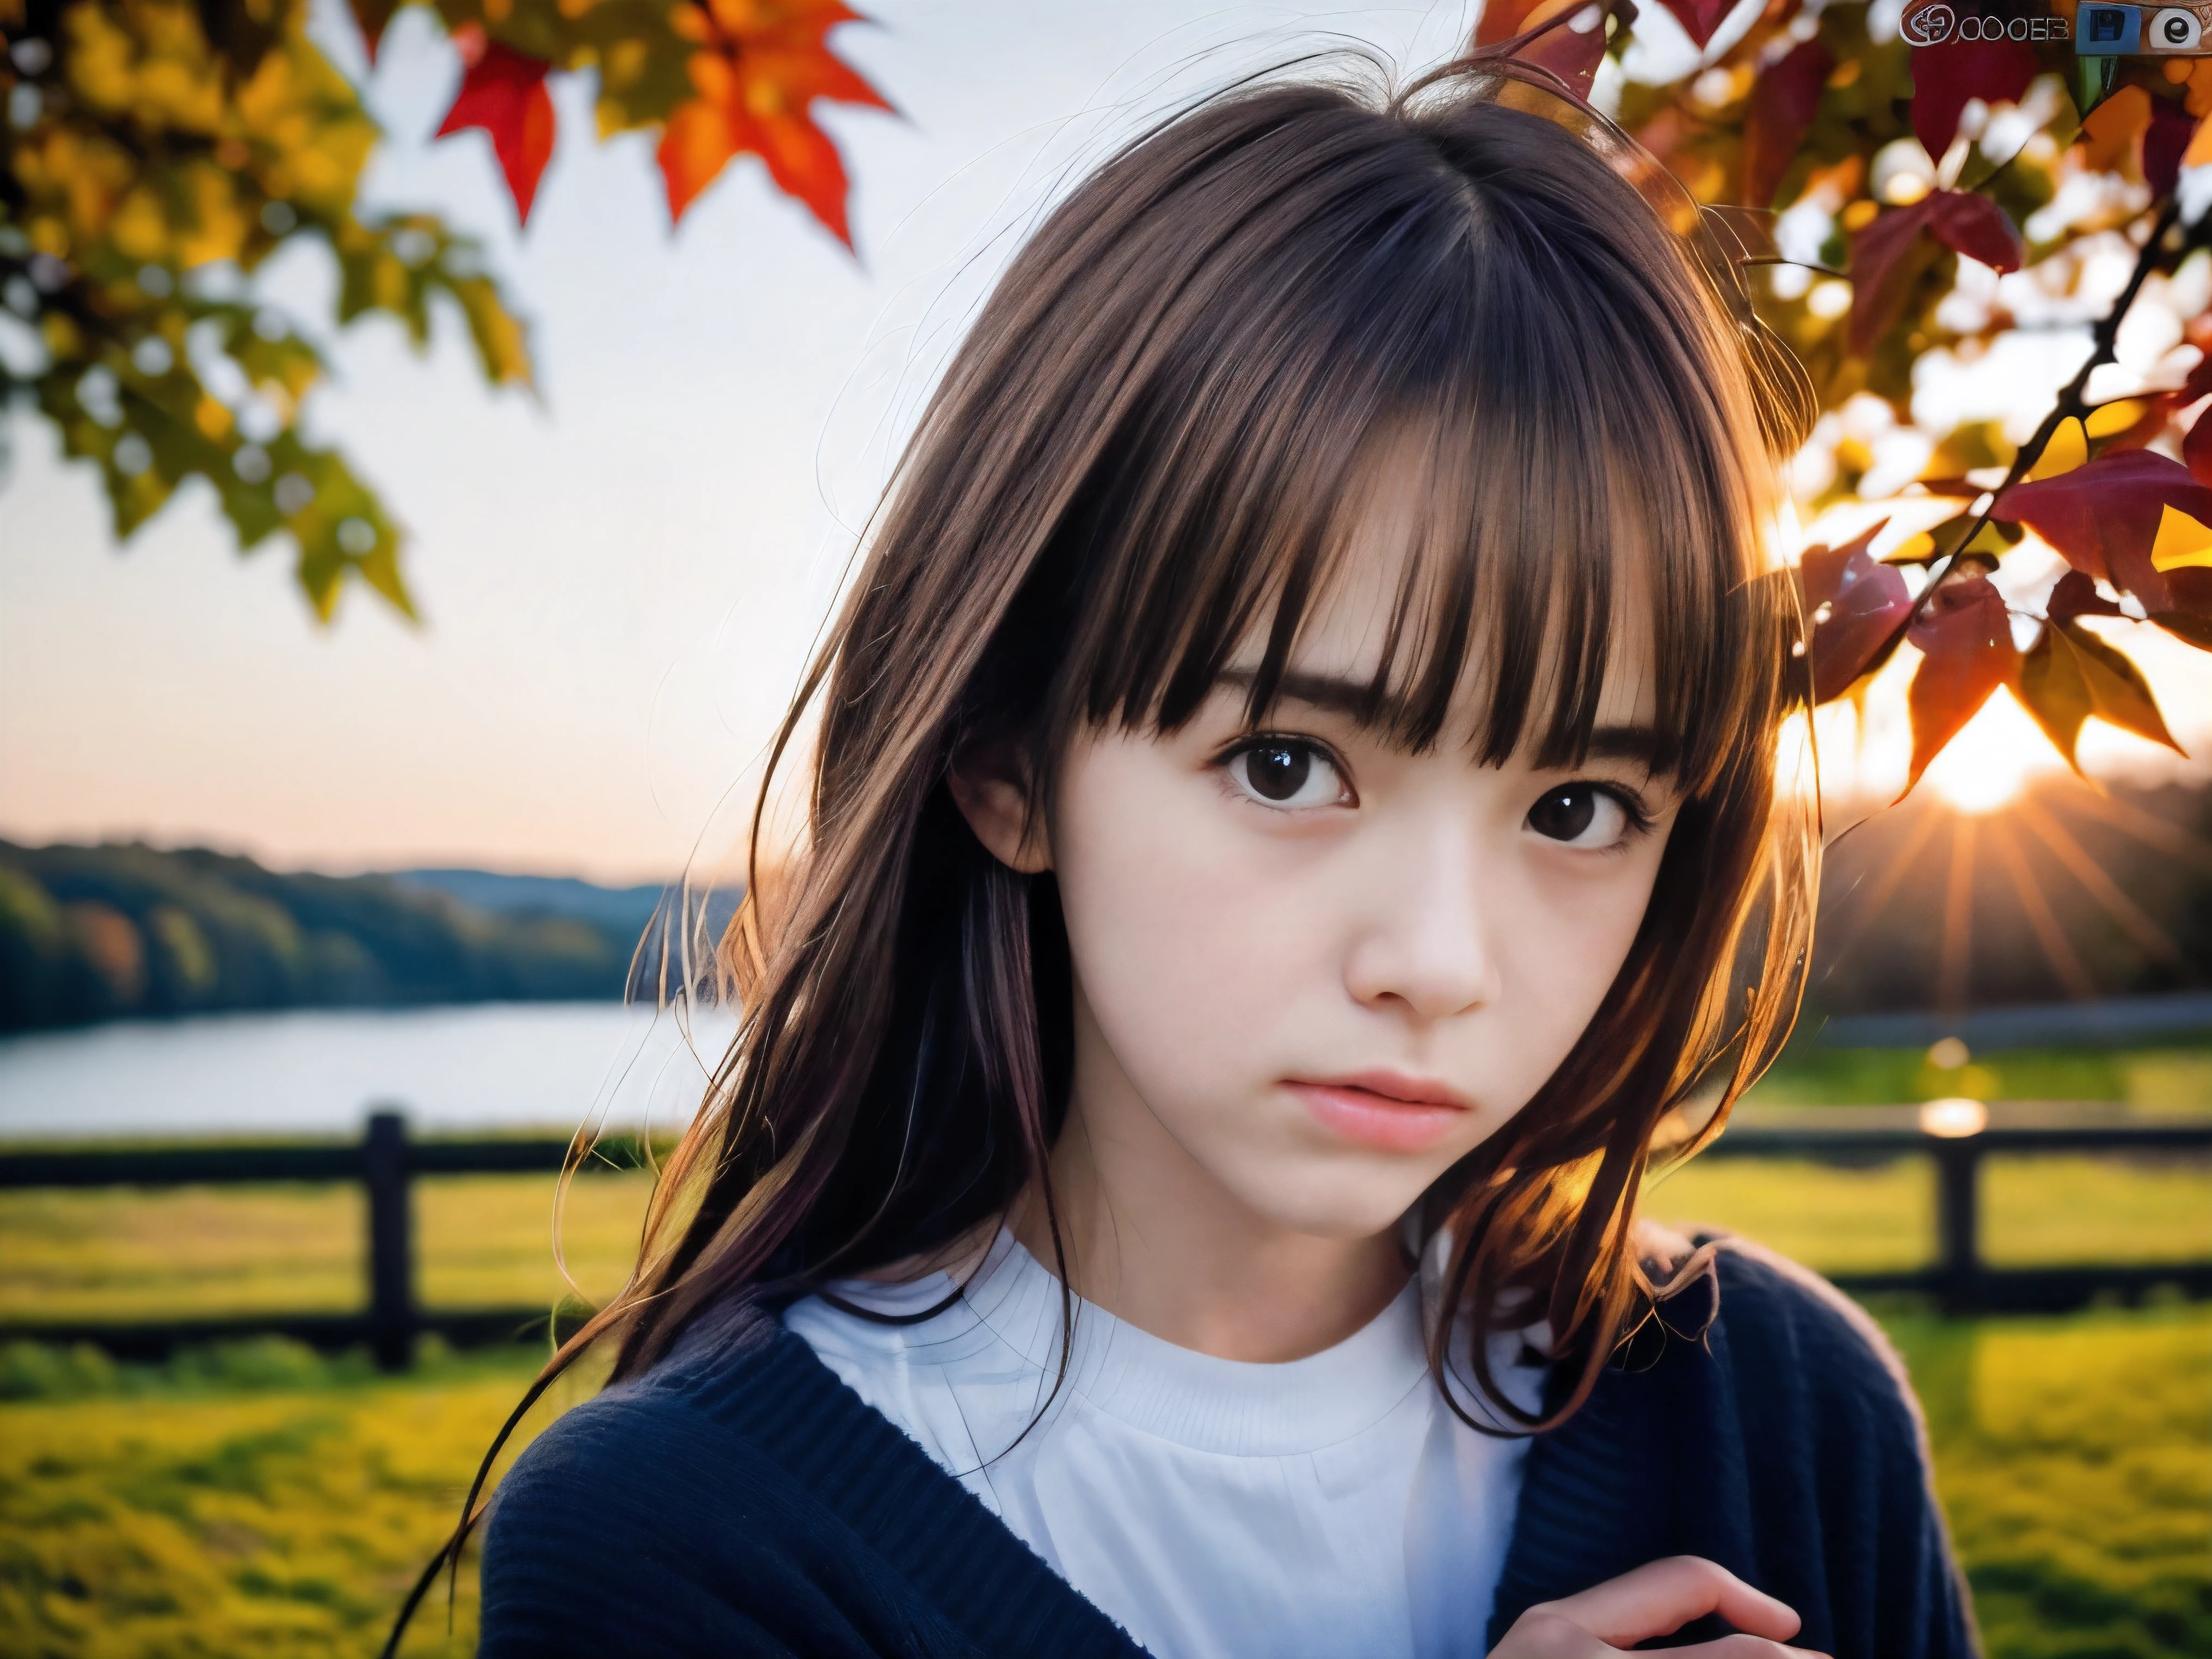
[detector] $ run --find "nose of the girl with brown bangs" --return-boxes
[1345,827,1504,1022]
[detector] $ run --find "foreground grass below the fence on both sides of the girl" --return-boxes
[0,1307,2212,1659]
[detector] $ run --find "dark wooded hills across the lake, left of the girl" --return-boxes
[0,840,663,1031]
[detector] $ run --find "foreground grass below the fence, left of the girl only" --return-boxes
[0,1343,583,1659]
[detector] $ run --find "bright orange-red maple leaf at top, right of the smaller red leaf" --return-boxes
[659,0,889,248]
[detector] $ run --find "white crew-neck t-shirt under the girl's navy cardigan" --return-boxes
[783,1232,1544,1659]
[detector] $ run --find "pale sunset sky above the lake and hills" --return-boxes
[0,0,2212,883]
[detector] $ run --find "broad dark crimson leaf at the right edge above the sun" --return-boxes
[1991,449,2212,617]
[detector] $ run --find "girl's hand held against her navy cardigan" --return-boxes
[1491,1555,1818,1659]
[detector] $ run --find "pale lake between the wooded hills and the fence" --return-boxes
[0,1002,734,1141]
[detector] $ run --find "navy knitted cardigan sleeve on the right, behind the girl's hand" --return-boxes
[1491,1239,1980,1659]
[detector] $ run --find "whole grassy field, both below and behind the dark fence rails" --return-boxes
[0,1159,2212,1659]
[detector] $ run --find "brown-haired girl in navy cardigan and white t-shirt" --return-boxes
[462,48,1973,1659]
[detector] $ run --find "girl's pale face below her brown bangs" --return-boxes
[1009,522,1677,1239]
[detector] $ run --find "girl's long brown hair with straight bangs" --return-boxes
[407,64,1816,1654]
